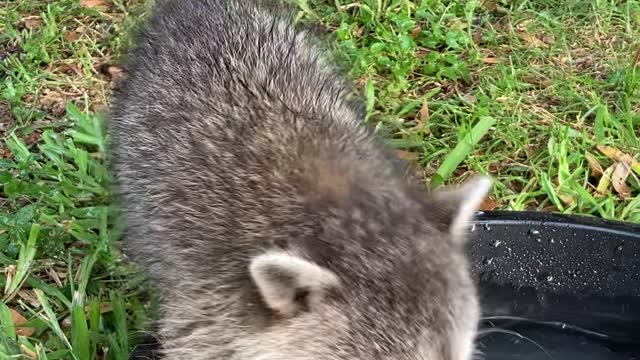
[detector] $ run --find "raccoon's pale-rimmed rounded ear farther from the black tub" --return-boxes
[249,251,339,317]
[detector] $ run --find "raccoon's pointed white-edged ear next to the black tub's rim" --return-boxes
[431,176,492,240]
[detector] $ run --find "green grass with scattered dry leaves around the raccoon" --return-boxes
[0,0,640,360]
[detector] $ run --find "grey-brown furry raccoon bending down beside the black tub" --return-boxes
[110,0,489,360]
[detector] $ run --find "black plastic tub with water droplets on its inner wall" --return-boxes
[469,212,640,360]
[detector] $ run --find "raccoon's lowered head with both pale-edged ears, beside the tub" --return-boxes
[244,178,490,360]
